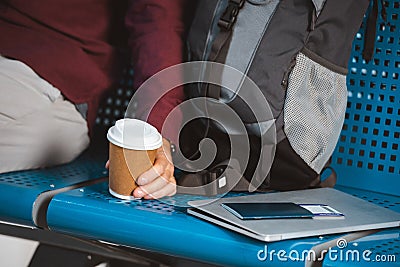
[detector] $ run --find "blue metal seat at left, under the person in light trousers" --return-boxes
[0,154,108,226]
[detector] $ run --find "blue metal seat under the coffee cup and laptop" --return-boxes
[47,182,346,266]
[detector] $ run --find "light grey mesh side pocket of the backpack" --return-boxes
[284,52,347,173]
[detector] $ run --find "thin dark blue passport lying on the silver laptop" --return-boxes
[221,202,313,220]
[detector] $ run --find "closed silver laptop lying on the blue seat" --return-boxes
[188,188,400,242]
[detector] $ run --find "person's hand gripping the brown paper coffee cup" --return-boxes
[133,139,176,199]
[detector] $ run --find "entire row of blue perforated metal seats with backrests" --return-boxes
[0,0,400,266]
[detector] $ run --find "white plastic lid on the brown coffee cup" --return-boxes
[107,119,162,150]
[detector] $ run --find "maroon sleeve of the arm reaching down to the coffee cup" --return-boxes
[125,0,187,147]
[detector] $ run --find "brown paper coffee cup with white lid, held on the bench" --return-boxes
[107,119,162,200]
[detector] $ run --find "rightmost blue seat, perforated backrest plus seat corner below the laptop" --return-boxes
[323,1,400,266]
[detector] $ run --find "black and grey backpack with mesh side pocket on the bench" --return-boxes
[178,0,369,194]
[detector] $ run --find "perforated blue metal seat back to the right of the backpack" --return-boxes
[333,0,400,195]
